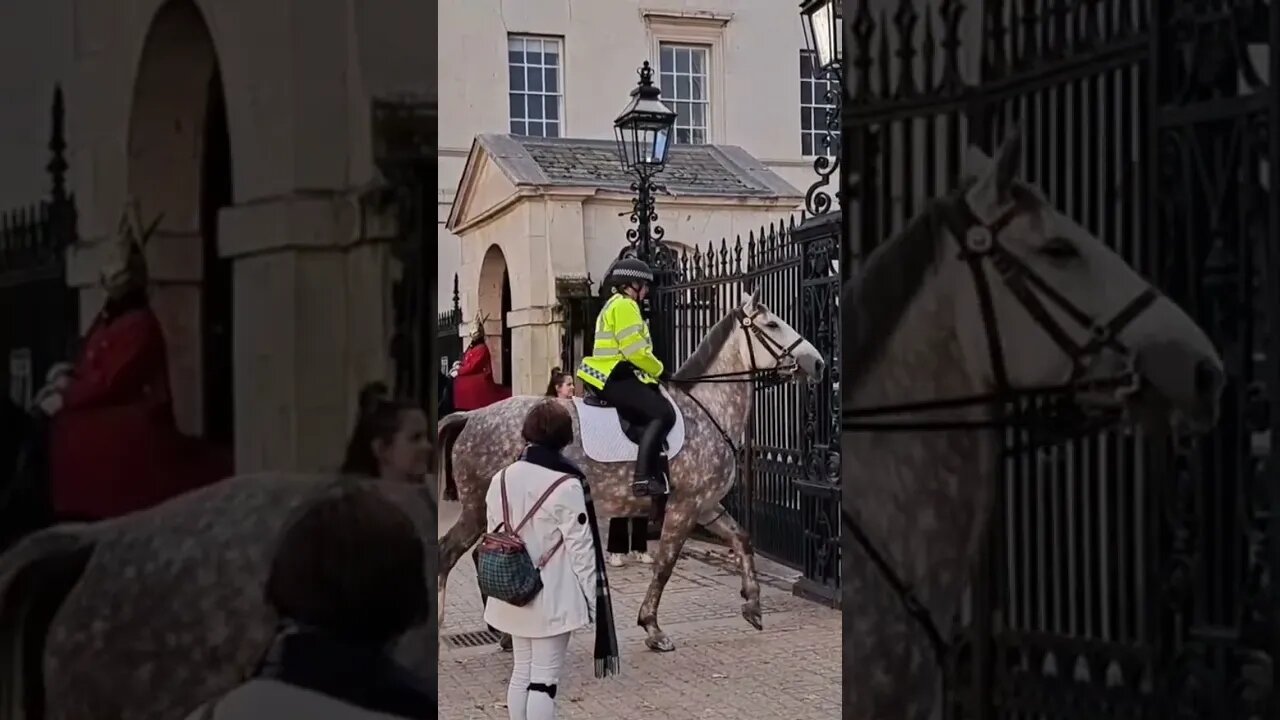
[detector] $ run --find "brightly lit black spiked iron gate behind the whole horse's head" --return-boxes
[650,214,840,602]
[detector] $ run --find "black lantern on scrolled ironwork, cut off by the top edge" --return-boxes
[800,0,845,215]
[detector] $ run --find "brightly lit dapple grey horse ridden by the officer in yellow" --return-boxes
[439,291,826,652]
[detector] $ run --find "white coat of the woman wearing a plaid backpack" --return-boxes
[484,461,596,638]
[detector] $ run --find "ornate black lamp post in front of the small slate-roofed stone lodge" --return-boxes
[613,60,676,265]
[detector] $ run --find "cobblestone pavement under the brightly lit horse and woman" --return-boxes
[439,506,840,720]
